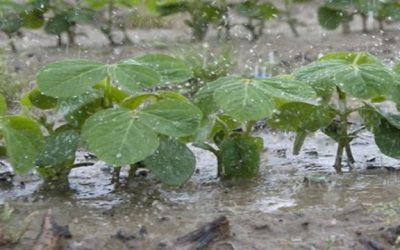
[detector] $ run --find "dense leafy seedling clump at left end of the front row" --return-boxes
[0,55,206,186]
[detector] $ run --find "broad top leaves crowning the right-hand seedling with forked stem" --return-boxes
[293,54,394,99]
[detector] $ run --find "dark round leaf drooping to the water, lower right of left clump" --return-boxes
[144,139,196,186]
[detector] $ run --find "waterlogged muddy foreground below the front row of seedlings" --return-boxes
[1,131,400,249]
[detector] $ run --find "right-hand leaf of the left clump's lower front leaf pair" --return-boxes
[139,99,202,137]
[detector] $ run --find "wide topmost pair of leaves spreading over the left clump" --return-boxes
[36,60,161,97]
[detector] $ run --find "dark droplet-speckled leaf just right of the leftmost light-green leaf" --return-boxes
[36,130,80,167]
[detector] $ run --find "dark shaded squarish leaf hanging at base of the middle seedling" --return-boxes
[218,137,263,178]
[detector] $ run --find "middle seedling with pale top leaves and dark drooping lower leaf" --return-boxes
[193,76,316,178]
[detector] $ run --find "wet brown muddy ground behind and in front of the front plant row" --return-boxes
[0,1,400,250]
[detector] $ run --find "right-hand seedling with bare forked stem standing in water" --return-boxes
[270,52,396,172]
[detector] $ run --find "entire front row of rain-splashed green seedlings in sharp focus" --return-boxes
[0,52,400,186]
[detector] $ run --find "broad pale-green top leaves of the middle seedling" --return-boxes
[200,77,315,121]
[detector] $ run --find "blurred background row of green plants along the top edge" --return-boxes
[5,0,400,51]
